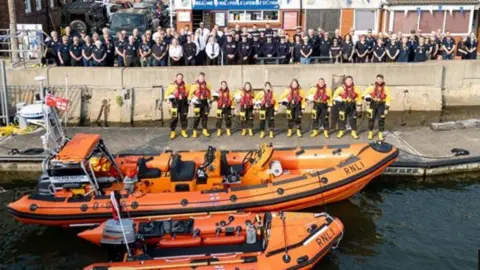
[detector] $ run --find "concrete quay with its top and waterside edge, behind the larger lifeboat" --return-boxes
[0,127,480,182]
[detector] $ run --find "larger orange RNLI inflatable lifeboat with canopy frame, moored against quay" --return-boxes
[8,134,398,226]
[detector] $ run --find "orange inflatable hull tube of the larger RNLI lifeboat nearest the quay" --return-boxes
[8,140,398,226]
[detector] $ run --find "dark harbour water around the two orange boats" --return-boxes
[0,179,480,270]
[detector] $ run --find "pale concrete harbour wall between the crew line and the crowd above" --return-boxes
[7,60,480,123]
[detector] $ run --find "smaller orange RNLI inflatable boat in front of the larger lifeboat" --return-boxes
[79,212,343,270]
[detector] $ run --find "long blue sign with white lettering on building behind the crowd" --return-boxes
[192,0,279,10]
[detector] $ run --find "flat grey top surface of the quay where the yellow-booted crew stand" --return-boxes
[0,127,480,159]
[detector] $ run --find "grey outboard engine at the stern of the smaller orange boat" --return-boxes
[100,219,136,261]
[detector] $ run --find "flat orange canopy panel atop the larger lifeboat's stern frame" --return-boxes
[57,133,100,162]
